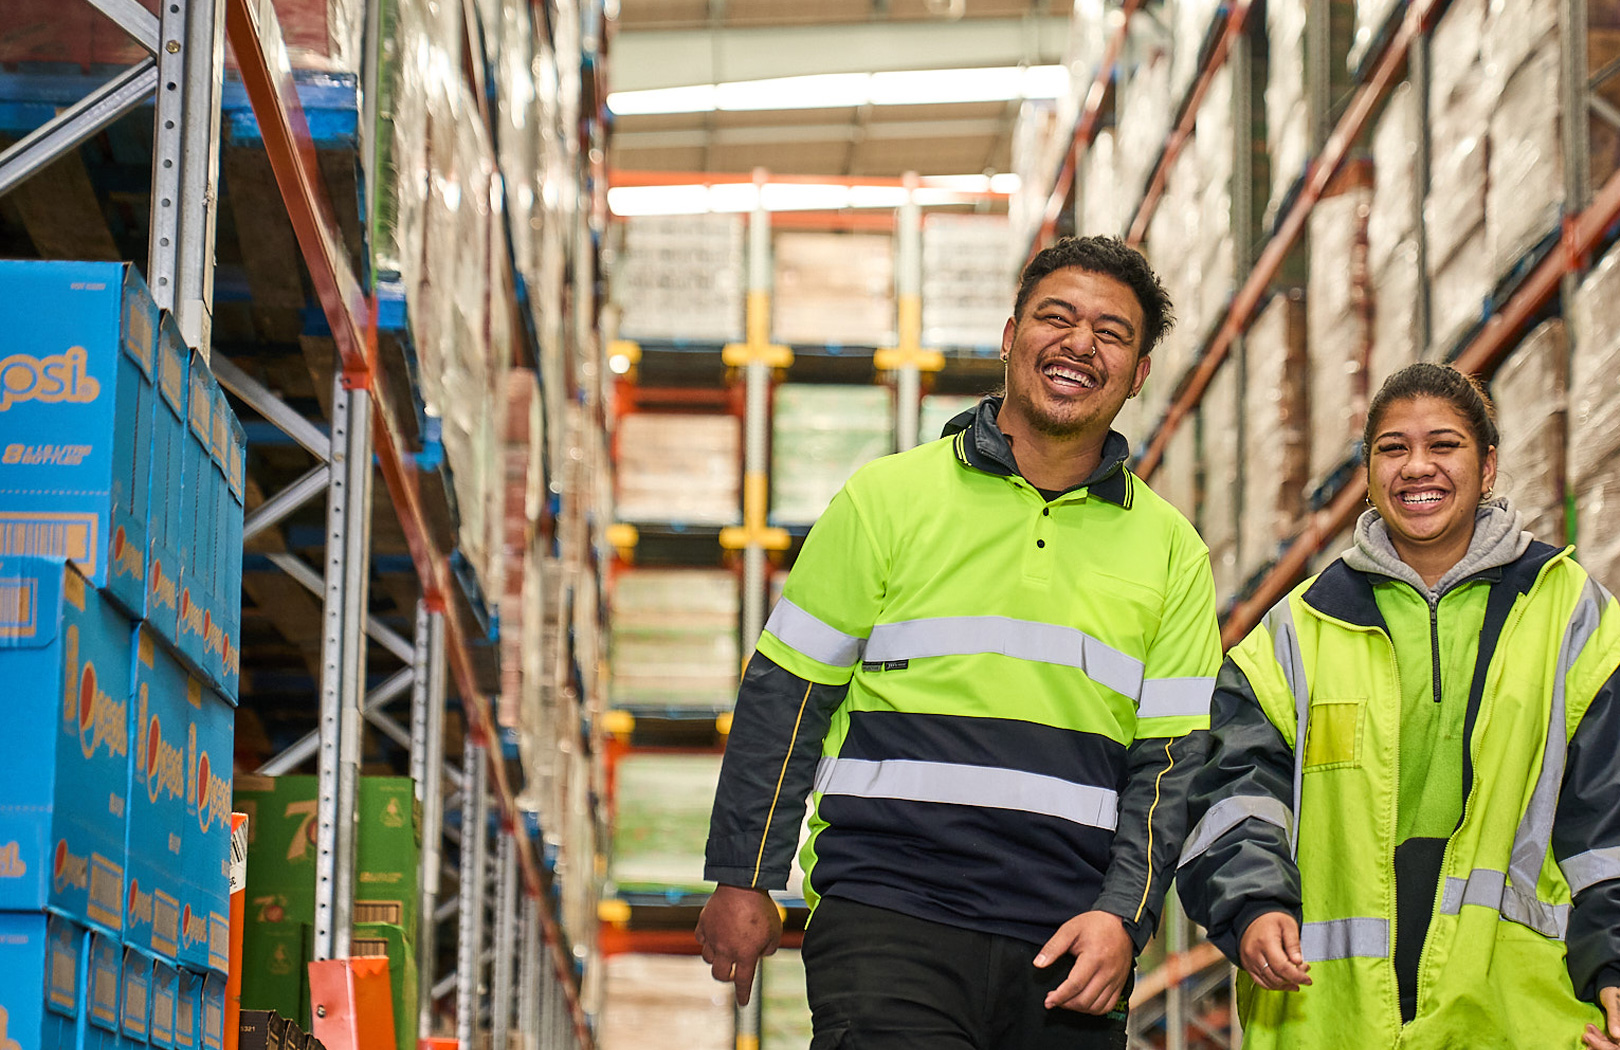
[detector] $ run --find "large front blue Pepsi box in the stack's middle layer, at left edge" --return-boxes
[0,557,130,933]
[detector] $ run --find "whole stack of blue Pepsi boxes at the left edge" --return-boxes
[0,263,245,1047]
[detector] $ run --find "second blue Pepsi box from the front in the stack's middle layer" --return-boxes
[123,625,196,963]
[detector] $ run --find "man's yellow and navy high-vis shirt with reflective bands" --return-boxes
[706,399,1220,946]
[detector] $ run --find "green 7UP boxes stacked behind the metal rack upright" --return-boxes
[235,776,421,1050]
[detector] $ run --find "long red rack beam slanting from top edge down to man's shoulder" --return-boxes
[1136,0,1447,480]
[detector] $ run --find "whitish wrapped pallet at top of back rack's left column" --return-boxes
[614,216,745,344]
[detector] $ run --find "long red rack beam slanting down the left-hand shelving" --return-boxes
[225,0,591,1047]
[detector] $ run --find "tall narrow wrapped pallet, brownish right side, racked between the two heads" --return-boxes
[1238,292,1311,578]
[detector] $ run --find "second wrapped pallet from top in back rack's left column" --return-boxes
[614,412,742,525]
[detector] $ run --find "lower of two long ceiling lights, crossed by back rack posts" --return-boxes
[608,175,1017,217]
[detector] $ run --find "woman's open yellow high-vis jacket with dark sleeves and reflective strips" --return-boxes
[1178,543,1620,1050]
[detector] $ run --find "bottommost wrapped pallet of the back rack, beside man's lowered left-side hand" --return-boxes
[596,954,735,1050]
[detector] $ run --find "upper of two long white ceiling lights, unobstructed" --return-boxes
[608,65,1069,117]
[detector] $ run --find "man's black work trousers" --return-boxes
[804,898,1126,1050]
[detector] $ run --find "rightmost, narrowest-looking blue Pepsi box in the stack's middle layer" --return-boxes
[180,679,237,974]
